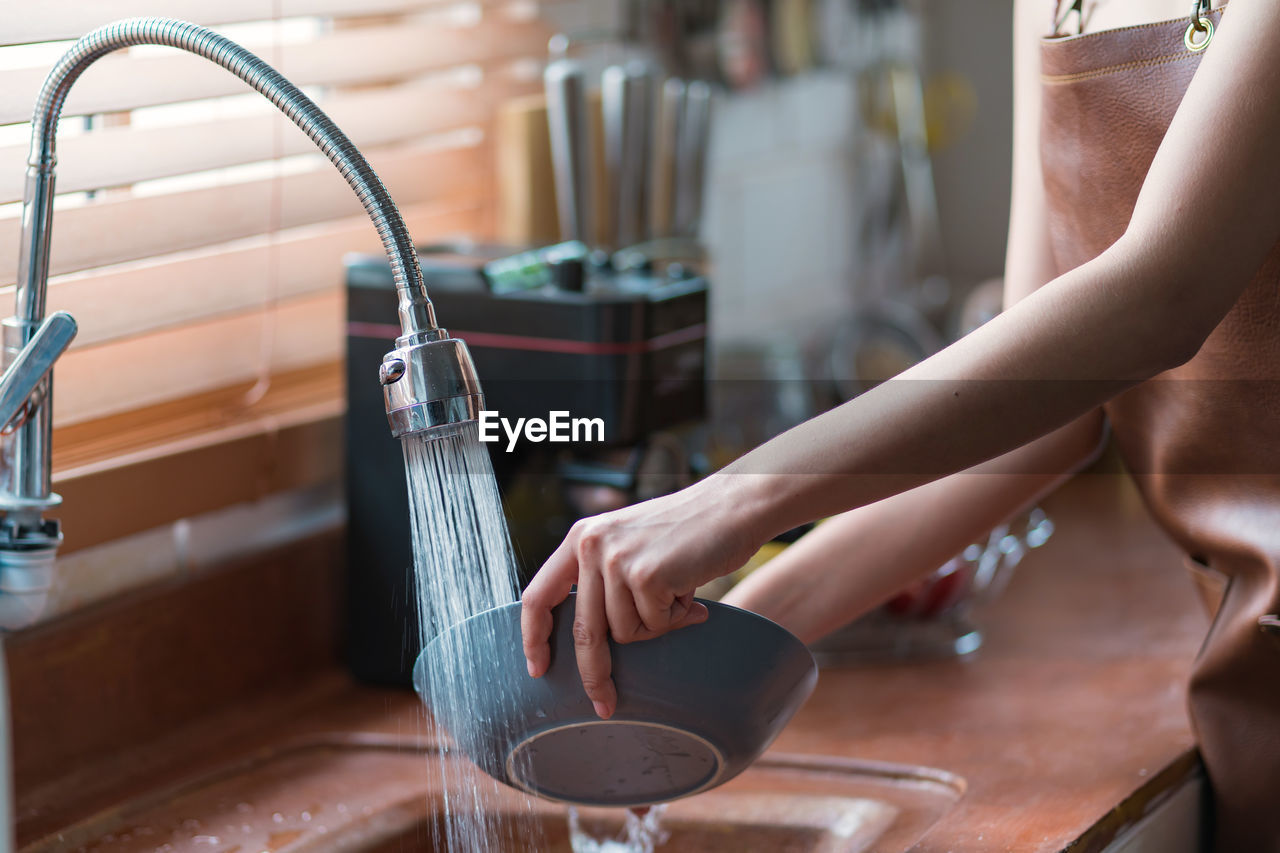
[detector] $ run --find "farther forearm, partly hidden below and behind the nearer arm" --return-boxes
[724,411,1102,643]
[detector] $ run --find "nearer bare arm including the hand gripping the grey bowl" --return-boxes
[522,0,1280,716]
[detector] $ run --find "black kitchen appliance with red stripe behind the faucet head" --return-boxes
[346,243,707,686]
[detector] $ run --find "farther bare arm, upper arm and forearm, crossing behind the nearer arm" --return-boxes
[724,0,1103,643]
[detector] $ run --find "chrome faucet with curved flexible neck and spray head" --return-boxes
[0,18,483,589]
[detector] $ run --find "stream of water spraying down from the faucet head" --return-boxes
[401,421,544,853]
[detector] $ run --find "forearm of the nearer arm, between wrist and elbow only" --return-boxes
[704,242,1188,539]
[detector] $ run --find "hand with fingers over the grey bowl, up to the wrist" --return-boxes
[520,476,774,719]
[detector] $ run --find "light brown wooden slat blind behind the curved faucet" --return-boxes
[0,0,550,476]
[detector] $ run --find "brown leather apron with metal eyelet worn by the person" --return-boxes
[1041,4,1280,853]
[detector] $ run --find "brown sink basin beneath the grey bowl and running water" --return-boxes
[22,736,964,853]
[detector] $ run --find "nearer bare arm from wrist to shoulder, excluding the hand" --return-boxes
[708,0,1280,545]
